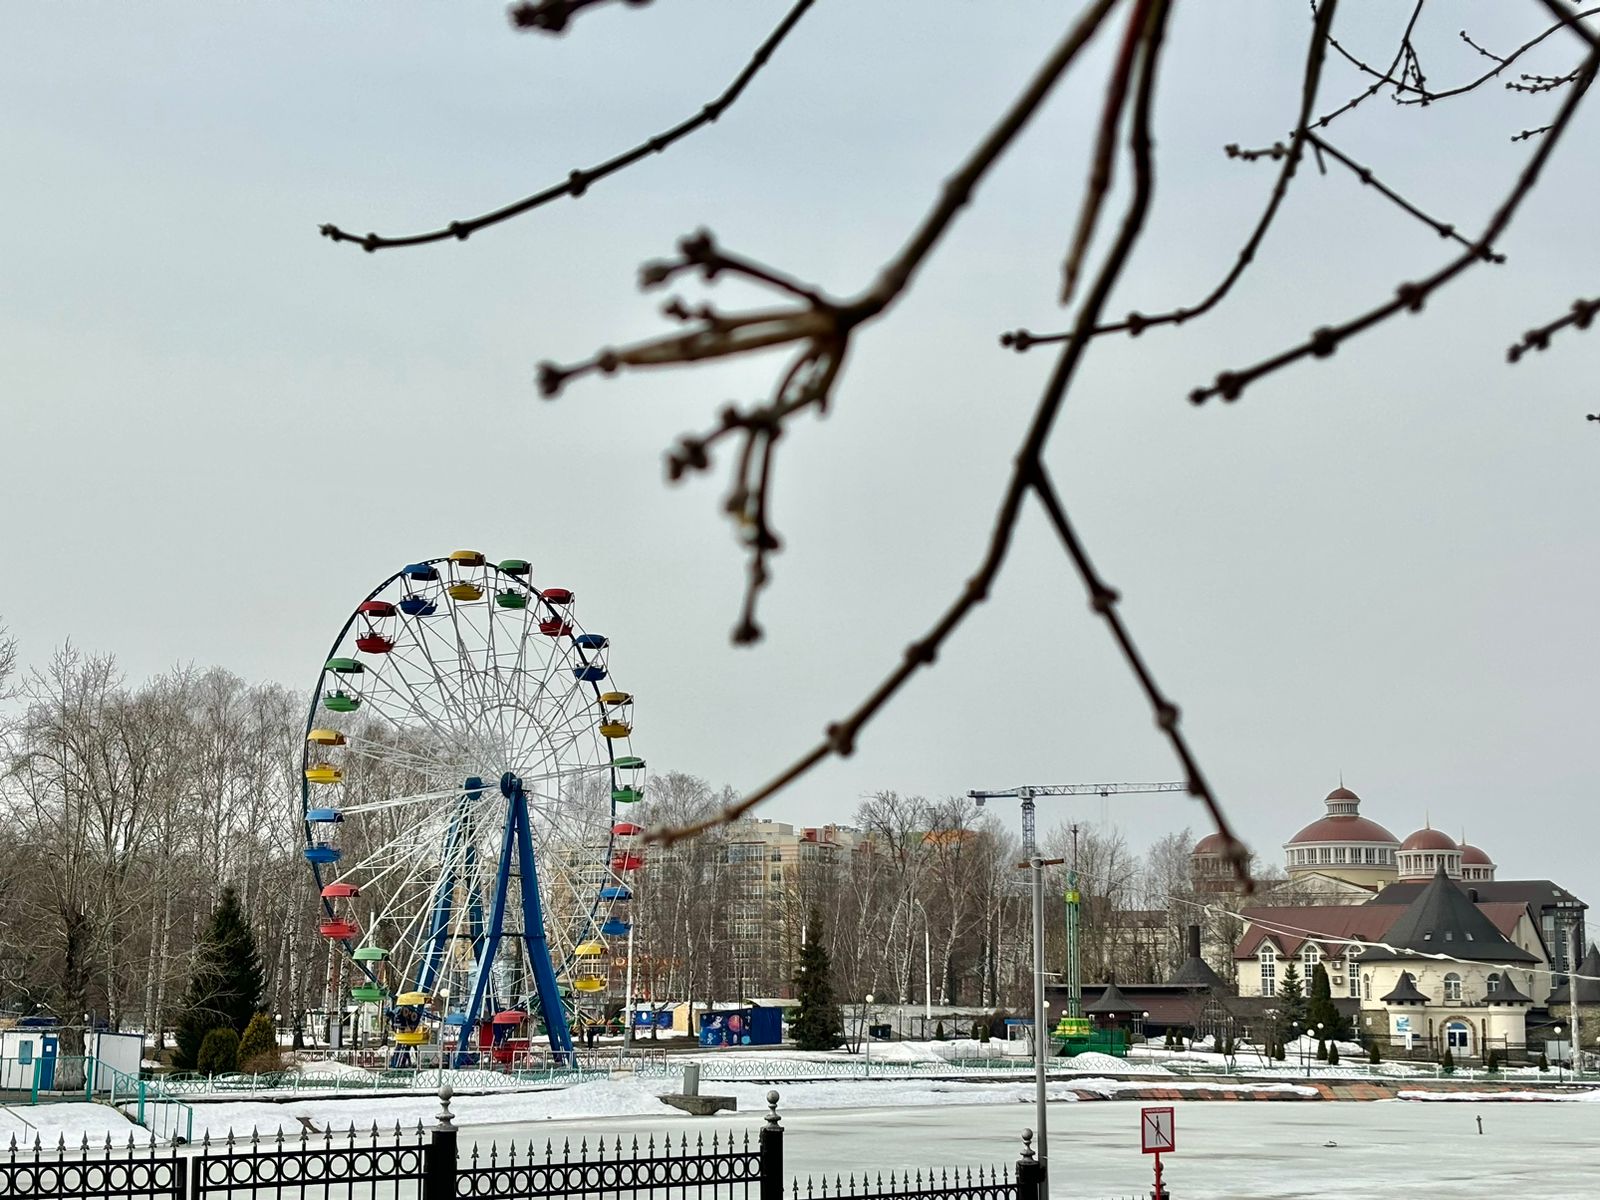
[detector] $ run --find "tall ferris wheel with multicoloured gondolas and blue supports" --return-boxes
[301,550,645,1066]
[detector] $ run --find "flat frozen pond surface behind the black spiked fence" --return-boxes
[462,1085,1600,1200]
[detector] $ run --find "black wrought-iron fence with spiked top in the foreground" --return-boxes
[0,1086,1045,1200]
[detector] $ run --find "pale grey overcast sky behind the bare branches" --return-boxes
[0,0,1600,901]
